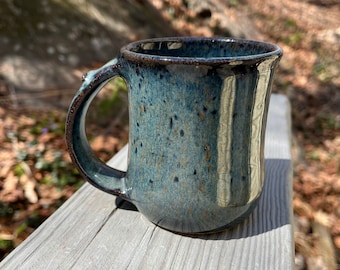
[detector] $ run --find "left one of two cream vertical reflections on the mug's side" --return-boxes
[217,76,236,207]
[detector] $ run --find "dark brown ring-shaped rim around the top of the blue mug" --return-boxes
[121,37,283,65]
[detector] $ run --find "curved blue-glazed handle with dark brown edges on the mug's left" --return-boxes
[65,58,127,197]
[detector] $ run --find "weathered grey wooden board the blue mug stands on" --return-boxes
[0,95,294,270]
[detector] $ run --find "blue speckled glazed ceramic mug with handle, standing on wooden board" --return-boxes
[66,37,282,234]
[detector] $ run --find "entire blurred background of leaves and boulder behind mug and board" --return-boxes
[0,0,340,269]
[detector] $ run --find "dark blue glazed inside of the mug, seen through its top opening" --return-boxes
[122,37,282,61]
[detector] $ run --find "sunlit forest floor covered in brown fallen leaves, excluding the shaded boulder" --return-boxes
[0,0,340,269]
